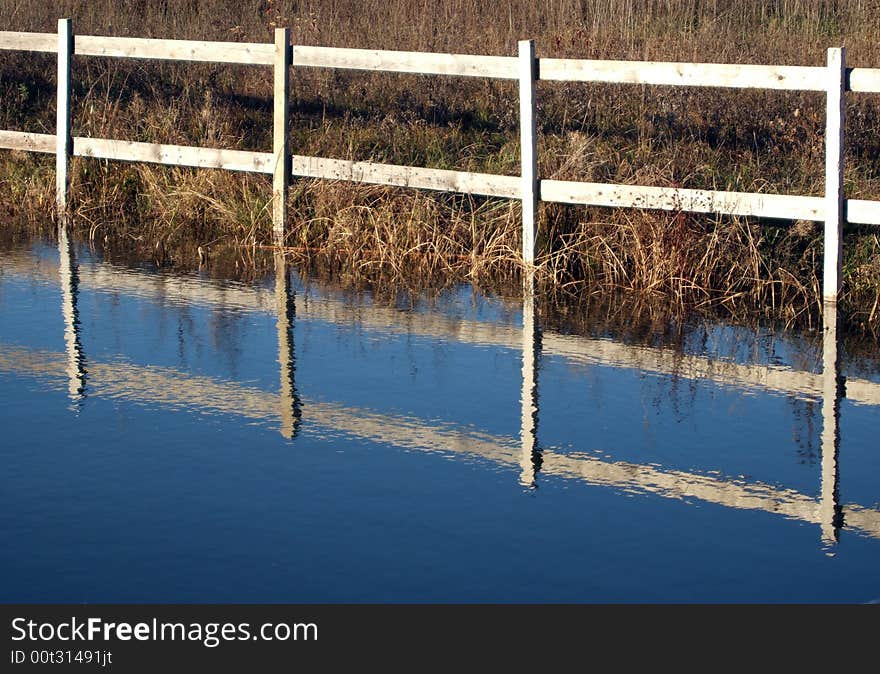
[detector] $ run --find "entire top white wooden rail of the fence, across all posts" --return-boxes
[0,31,880,93]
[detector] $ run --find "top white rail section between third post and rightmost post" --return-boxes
[538,58,825,91]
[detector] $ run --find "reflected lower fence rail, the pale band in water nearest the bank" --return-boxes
[13,256,880,405]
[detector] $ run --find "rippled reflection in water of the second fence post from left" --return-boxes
[275,250,302,439]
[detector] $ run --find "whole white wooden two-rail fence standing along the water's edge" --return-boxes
[0,19,880,300]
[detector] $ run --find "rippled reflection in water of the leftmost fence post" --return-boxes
[58,218,86,403]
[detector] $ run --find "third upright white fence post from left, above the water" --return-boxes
[519,40,539,265]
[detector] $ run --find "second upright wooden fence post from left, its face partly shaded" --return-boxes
[272,28,291,245]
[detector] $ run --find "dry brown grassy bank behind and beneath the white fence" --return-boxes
[0,0,880,334]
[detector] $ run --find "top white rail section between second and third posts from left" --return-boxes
[293,45,518,80]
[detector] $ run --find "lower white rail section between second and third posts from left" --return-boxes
[291,155,521,199]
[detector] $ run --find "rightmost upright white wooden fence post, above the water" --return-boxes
[822,48,846,301]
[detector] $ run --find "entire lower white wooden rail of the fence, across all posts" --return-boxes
[0,131,880,225]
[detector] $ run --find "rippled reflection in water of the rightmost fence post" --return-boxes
[819,302,844,545]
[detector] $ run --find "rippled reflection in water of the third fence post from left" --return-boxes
[519,272,542,489]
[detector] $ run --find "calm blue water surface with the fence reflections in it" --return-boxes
[0,234,880,602]
